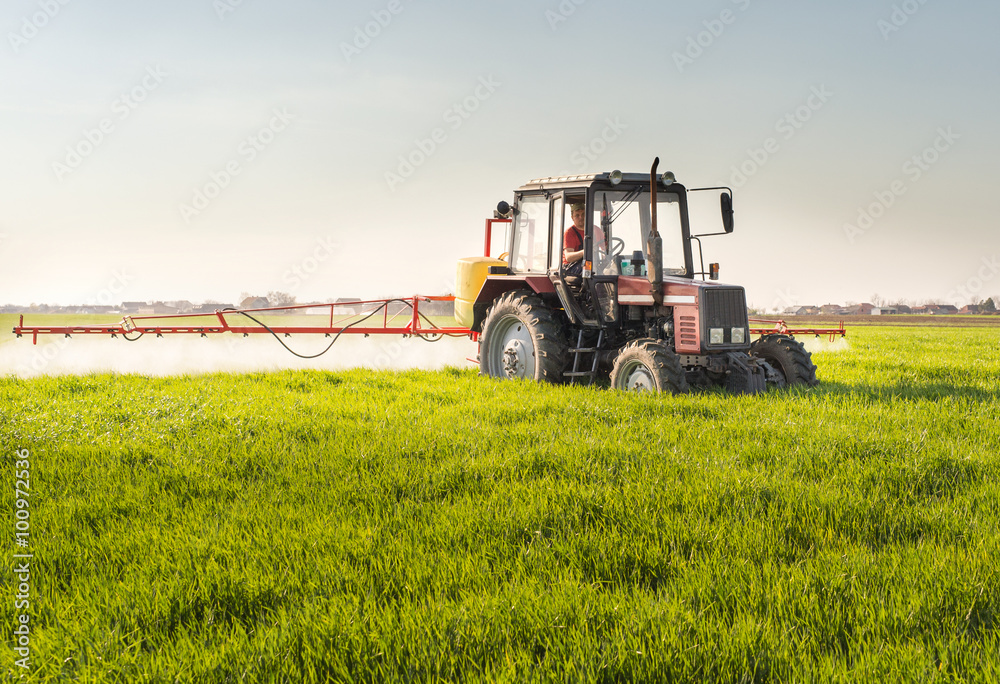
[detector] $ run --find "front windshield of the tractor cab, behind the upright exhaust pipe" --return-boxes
[594,187,687,276]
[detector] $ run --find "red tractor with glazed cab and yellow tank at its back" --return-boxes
[455,160,818,394]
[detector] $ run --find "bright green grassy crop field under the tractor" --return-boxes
[0,327,1000,682]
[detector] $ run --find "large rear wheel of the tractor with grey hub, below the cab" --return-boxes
[479,290,568,383]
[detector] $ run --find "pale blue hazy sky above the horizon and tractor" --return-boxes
[0,0,1000,309]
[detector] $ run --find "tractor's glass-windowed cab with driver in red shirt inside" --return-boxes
[484,171,712,328]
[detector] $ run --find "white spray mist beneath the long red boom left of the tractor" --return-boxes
[0,334,477,378]
